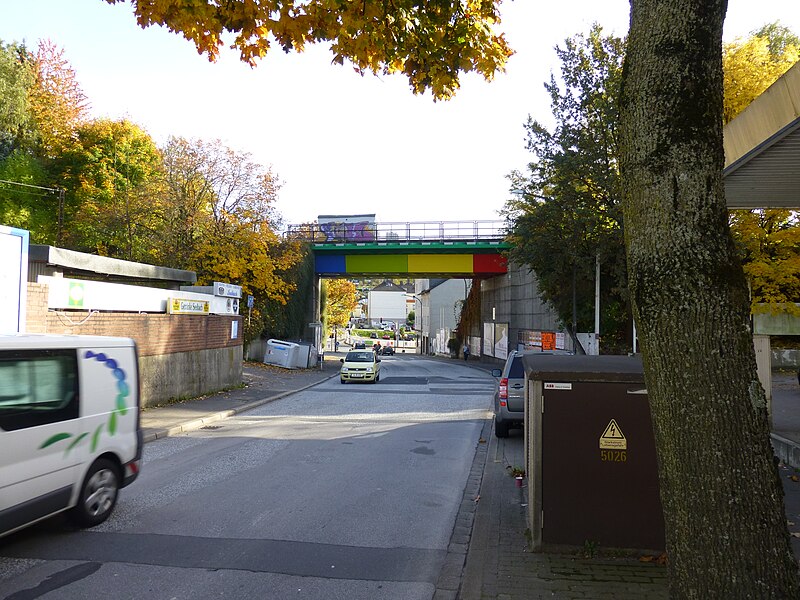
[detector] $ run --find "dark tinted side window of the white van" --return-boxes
[0,350,79,431]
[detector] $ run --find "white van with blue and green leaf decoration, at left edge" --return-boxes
[0,334,142,536]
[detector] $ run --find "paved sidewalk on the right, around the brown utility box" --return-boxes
[454,361,800,600]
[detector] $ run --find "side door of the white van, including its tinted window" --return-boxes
[0,349,81,531]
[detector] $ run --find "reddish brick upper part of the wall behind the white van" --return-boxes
[26,283,243,356]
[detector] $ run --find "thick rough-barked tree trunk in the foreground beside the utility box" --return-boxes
[621,0,800,600]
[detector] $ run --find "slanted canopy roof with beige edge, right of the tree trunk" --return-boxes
[723,62,800,209]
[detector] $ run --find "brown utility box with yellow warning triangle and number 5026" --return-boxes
[523,354,664,550]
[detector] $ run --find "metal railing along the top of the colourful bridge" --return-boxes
[284,221,506,244]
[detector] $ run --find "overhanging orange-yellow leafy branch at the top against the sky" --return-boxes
[106,0,512,100]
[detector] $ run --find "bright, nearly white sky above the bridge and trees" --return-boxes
[0,0,800,223]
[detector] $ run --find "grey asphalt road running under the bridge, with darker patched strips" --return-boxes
[0,355,494,600]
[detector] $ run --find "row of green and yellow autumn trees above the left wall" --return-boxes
[0,41,310,339]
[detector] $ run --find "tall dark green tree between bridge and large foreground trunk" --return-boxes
[505,24,630,351]
